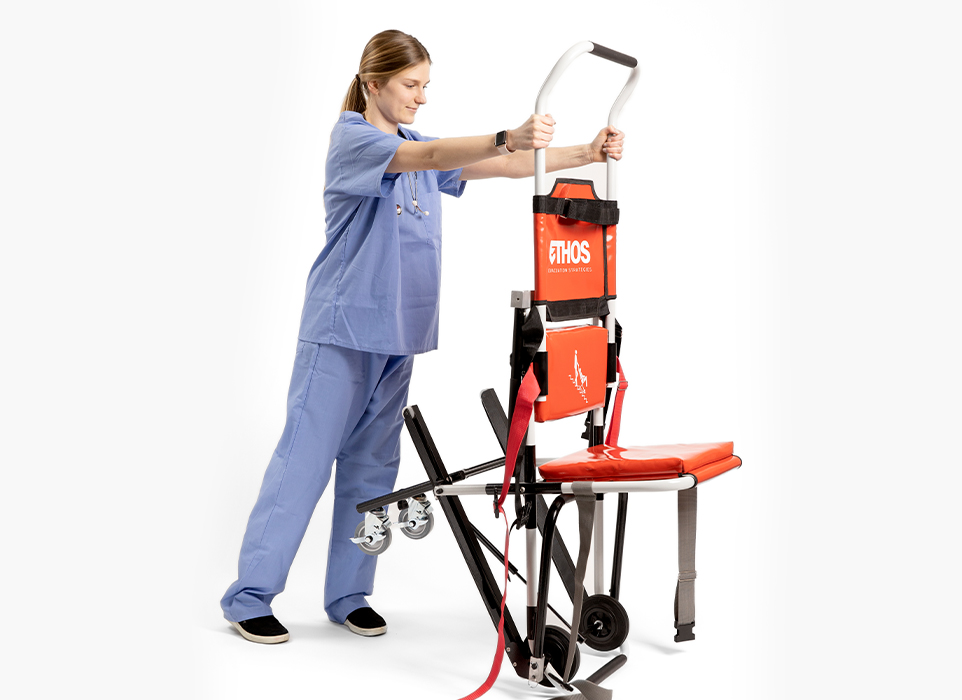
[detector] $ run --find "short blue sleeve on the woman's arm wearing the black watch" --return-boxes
[327,112,404,197]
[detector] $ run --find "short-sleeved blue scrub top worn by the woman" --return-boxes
[299,112,465,355]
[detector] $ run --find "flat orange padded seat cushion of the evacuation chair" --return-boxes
[539,442,742,482]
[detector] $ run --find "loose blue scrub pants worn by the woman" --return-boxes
[221,341,414,623]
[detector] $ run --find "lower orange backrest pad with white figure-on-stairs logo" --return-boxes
[534,326,608,423]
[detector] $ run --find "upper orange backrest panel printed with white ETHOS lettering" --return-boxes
[533,182,617,301]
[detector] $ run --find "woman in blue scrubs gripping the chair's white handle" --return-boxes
[221,30,624,643]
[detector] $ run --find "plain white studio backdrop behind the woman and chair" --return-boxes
[0,0,962,699]
